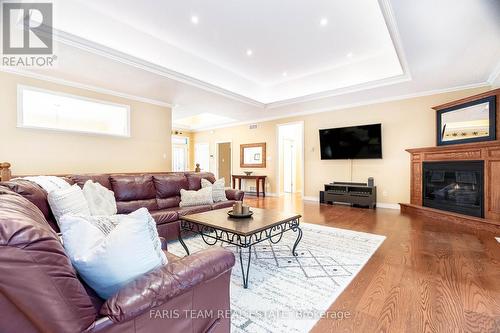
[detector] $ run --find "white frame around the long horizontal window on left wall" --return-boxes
[17,84,131,138]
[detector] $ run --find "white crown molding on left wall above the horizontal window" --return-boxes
[0,66,172,108]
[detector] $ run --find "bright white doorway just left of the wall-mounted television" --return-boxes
[277,122,304,195]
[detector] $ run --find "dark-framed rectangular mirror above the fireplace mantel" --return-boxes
[437,96,496,146]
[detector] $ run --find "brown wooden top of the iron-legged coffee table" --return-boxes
[181,208,301,236]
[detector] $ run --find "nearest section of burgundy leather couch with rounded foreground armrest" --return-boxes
[0,185,234,333]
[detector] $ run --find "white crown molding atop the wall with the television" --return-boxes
[186,82,491,133]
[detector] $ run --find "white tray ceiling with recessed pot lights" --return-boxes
[1,0,500,129]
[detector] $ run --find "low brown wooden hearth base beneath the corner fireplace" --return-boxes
[399,203,500,232]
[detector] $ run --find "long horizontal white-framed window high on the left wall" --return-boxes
[17,86,130,137]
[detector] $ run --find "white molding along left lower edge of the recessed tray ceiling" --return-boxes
[54,29,265,108]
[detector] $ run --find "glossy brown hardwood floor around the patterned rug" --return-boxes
[245,196,500,333]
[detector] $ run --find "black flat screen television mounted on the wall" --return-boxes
[319,124,382,160]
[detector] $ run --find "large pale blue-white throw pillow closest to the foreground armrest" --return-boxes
[61,208,167,299]
